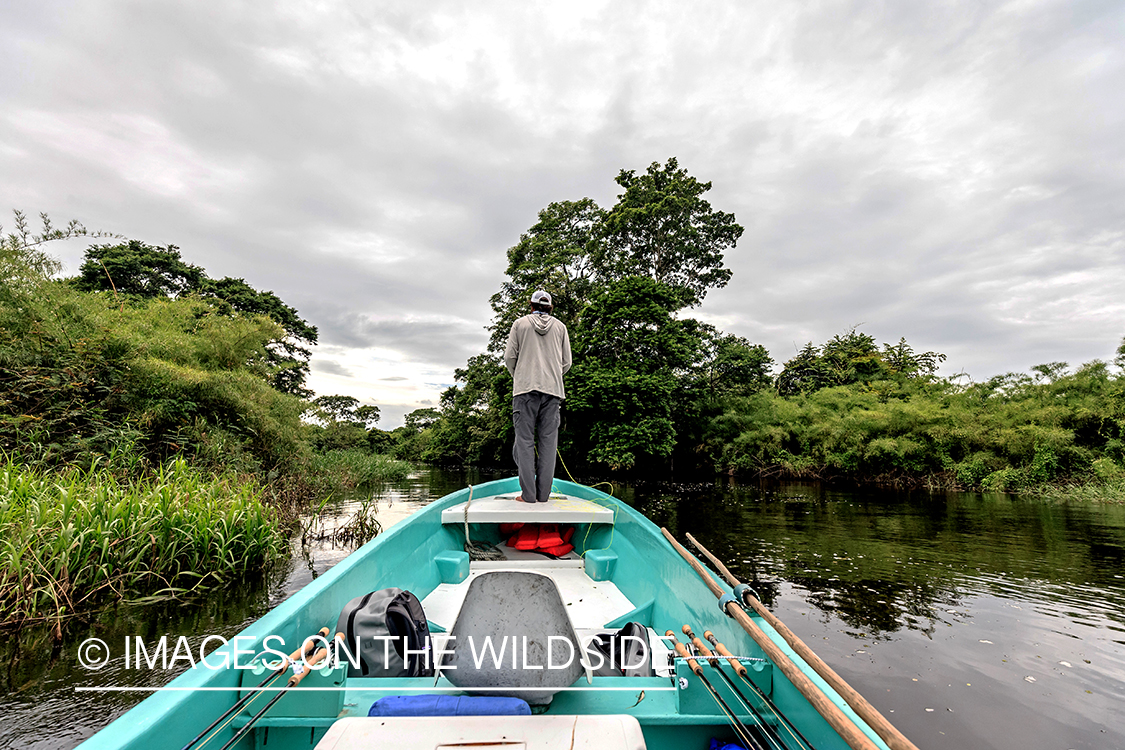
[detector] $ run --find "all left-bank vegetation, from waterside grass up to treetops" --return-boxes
[0,214,410,624]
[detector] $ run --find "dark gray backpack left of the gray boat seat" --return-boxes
[336,588,433,677]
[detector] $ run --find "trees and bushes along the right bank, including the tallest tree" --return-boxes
[380,160,1125,500]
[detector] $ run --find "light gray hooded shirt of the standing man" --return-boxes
[504,313,570,398]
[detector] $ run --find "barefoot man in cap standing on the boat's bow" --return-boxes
[504,289,570,503]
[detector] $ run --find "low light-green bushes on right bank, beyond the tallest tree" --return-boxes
[707,357,1125,491]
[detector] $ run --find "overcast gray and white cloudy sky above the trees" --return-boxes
[0,0,1125,427]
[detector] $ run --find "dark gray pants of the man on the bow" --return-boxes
[512,390,563,503]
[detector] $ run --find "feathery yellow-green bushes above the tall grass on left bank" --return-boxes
[0,279,304,468]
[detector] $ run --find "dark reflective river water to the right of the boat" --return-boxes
[629,485,1125,749]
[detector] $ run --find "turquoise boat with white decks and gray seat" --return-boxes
[74,478,912,750]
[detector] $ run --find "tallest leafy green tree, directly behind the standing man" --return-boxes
[434,159,751,469]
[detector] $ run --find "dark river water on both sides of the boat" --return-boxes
[0,469,1125,750]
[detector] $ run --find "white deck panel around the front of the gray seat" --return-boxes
[422,566,636,632]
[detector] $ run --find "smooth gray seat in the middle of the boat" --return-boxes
[438,570,592,704]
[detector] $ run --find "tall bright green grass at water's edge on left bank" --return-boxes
[0,457,286,625]
